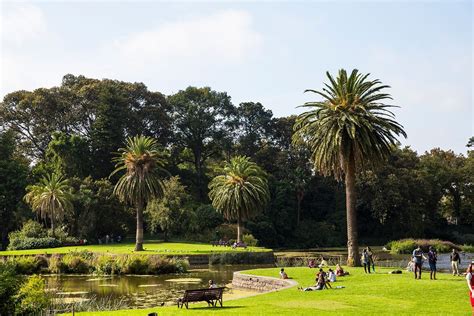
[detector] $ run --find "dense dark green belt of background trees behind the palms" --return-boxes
[0,75,474,252]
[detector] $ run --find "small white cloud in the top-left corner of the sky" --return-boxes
[0,4,46,45]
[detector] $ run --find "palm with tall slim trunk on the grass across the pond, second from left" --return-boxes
[110,136,167,251]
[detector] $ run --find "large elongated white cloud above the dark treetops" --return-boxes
[113,10,262,65]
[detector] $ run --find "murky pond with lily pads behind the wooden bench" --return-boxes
[45,265,273,308]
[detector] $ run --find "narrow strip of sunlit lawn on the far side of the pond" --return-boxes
[0,241,271,256]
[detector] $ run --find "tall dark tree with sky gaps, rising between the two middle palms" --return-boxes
[168,87,235,200]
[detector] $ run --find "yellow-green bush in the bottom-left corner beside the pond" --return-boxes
[15,275,52,315]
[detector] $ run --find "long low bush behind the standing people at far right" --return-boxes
[385,238,461,254]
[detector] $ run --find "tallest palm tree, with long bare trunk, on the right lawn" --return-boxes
[293,69,406,266]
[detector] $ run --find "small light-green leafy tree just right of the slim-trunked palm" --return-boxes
[146,176,191,240]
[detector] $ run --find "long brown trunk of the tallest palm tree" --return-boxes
[345,152,360,267]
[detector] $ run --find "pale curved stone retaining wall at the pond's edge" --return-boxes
[232,272,298,292]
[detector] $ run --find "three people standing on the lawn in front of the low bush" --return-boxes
[408,246,461,280]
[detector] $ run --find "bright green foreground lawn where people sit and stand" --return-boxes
[63,268,471,316]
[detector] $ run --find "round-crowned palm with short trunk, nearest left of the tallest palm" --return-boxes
[209,156,270,242]
